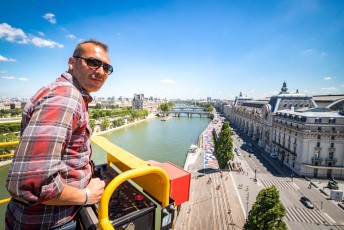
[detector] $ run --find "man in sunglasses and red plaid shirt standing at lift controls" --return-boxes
[6,40,113,230]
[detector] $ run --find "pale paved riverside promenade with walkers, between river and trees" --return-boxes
[175,120,245,230]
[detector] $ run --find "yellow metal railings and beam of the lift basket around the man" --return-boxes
[0,136,170,230]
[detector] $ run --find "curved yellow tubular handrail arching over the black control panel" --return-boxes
[98,166,170,230]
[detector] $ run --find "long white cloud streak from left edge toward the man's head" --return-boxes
[0,23,63,48]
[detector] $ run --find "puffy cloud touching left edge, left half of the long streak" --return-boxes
[0,23,30,44]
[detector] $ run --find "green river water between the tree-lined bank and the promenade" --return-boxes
[0,116,210,222]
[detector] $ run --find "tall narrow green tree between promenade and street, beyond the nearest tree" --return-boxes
[215,121,234,169]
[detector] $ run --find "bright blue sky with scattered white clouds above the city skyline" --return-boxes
[0,0,344,99]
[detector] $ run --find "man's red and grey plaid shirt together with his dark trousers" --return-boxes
[6,73,92,229]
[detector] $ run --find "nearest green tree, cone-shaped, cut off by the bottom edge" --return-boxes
[244,186,287,230]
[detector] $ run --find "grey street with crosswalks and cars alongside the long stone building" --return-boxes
[228,125,344,230]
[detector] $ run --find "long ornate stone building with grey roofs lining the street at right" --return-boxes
[223,82,344,179]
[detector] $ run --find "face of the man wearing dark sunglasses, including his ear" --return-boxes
[68,43,110,93]
